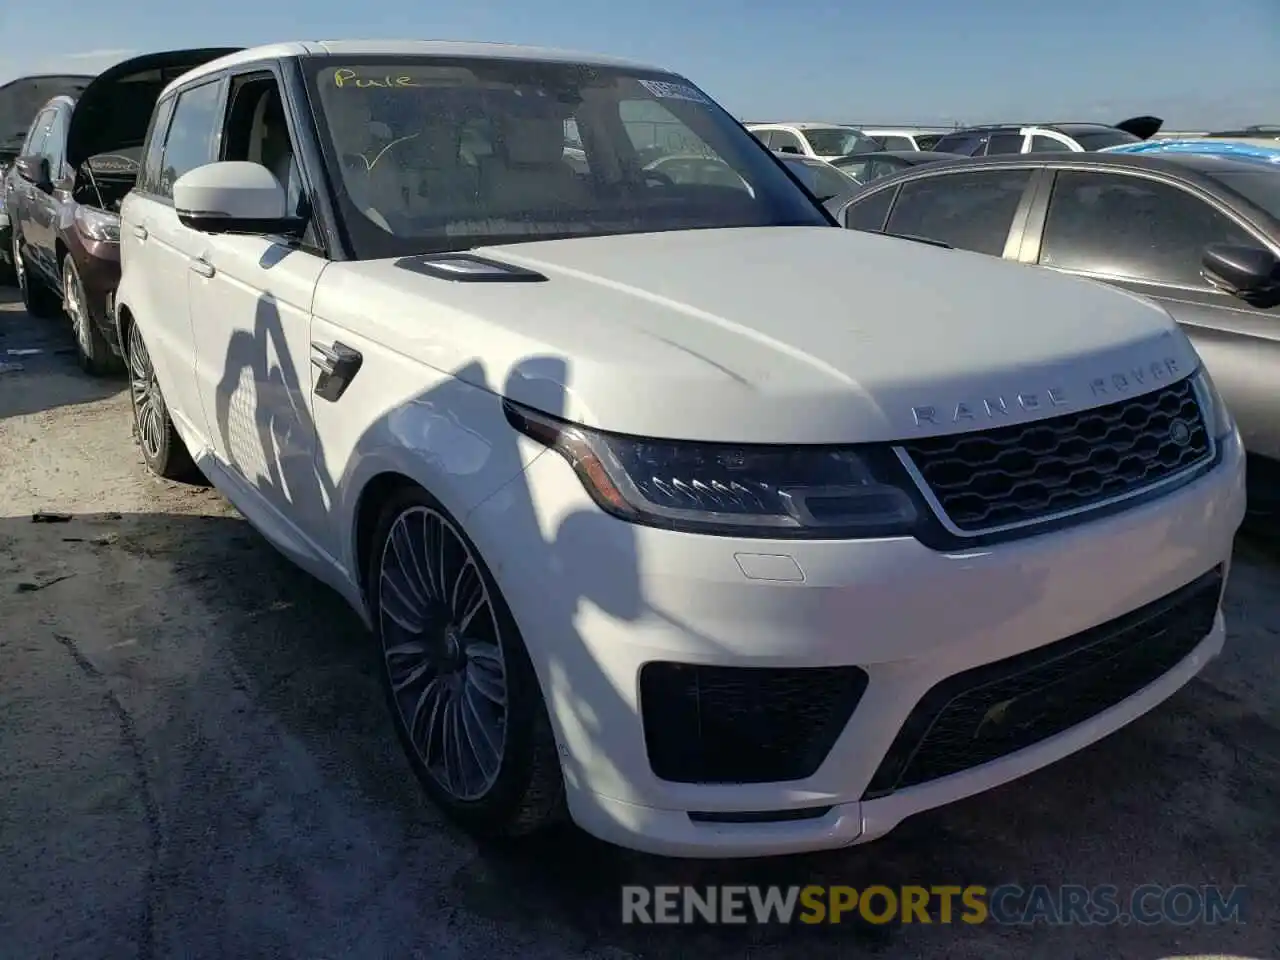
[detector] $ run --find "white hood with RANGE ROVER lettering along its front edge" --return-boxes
[315,227,1198,443]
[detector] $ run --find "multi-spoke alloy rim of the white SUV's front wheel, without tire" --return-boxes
[378,507,507,801]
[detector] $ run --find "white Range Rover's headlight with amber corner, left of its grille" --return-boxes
[506,401,919,539]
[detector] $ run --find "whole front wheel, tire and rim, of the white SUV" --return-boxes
[367,488,564,838]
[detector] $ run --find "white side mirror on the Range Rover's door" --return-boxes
[173,160,302,236]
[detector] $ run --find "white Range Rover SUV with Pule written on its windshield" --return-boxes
[116,42,1244,856]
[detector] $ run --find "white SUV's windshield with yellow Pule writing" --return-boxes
[307,56,831,259]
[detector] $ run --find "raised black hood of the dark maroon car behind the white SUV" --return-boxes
[67,47,239,169]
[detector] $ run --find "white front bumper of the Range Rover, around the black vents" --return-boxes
[466,436,1244,856]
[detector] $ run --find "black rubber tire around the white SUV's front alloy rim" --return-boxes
[366,485,564,840]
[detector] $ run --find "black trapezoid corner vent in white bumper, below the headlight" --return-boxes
[640,663,867,783]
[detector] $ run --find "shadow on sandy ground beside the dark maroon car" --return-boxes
[0,287,128,420]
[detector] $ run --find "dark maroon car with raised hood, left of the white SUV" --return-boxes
[6,47,234,374]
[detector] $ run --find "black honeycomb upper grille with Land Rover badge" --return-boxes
[905,378,1212,531]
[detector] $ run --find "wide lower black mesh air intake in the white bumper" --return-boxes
[863,570,1222,800]
